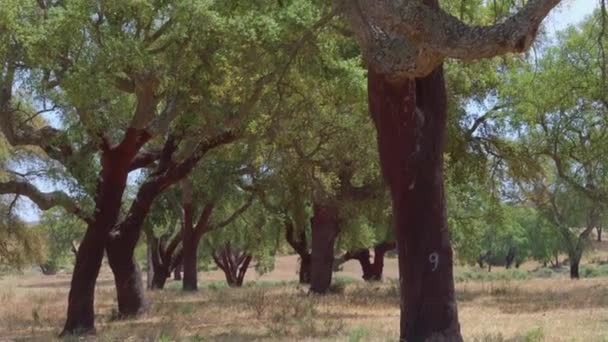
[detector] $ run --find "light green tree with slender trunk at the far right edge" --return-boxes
[500,12,608,278]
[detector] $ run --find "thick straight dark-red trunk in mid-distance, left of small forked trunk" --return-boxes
[310,203,339,294]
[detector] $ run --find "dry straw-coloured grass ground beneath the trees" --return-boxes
[0,245,608,342]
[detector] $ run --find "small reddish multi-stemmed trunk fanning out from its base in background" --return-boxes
[213,242,252,287]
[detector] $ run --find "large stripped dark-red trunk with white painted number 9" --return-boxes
[368,67,462,341]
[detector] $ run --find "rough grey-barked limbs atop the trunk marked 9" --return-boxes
[343,0,561,78]
